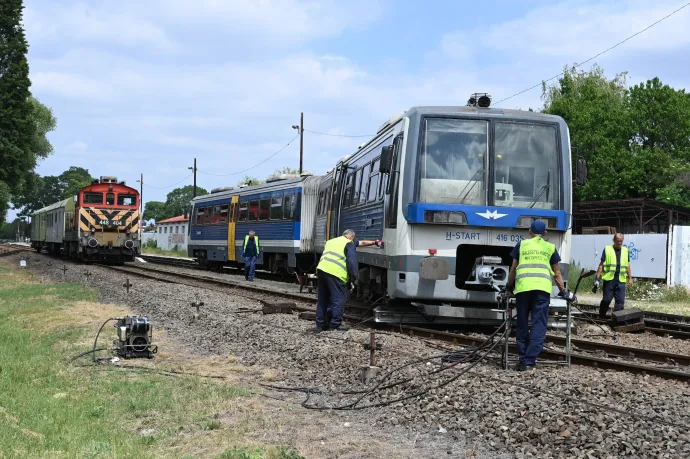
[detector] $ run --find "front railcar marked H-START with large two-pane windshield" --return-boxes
[314,101,584,323]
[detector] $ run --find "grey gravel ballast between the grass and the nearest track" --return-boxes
[8,254,690,458]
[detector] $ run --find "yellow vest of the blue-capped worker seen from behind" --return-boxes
[515,236,556,294]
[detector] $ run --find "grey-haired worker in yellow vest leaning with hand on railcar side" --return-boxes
[316,229,381,331]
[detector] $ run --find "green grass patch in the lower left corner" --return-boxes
[0,261,299,459]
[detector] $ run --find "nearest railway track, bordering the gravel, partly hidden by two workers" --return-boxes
[95,265,690,381]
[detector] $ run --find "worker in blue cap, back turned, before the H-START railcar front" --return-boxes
[506,220,575,371]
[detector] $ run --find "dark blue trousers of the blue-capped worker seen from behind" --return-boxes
[515,290,551,365]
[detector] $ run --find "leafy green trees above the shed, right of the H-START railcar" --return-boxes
[542,66,690,205]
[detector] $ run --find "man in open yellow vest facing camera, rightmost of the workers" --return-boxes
[592,233,633,318]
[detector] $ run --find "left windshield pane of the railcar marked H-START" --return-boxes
[419,118,489,205]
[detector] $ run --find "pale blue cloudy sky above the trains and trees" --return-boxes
[9,0,690,218]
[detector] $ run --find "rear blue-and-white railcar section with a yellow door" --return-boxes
[187,176,321,272]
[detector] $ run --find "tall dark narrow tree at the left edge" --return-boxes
[0,0,36,221]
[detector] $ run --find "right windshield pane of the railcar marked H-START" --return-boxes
[494,122,560,209]
